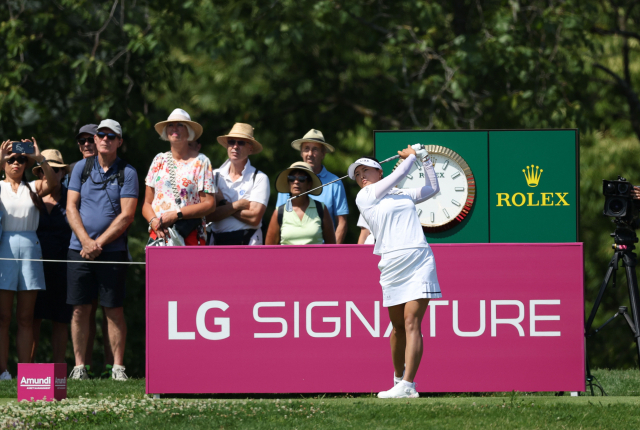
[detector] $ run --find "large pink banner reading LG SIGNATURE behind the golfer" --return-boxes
[146,243,585,393]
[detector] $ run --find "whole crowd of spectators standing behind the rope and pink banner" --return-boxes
[0,109,373,381]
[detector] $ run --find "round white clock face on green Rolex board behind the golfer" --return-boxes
[396,145,476,232]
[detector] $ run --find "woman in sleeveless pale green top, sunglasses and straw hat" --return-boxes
[266,161,336,245]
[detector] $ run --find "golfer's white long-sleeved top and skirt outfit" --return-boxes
[356,154,442,307]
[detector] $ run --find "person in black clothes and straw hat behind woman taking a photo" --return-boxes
[31,149,73,363]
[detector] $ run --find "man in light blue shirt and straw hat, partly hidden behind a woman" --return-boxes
[276,130,349,243]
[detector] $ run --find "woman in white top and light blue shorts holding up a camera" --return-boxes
[0,138,56,380]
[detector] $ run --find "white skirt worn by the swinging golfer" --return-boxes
[378,247,442,307]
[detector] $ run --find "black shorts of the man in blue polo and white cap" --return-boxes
[67,249,129,308]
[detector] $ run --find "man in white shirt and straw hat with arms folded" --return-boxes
[207,123,271,245]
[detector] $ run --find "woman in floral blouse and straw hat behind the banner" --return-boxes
[142,109,216,245]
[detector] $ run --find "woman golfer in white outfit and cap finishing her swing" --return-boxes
[349,146,442,399]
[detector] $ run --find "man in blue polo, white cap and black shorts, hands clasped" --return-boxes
[67,119,139,381]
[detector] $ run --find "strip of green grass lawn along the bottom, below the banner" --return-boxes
[0,370,640,430]
